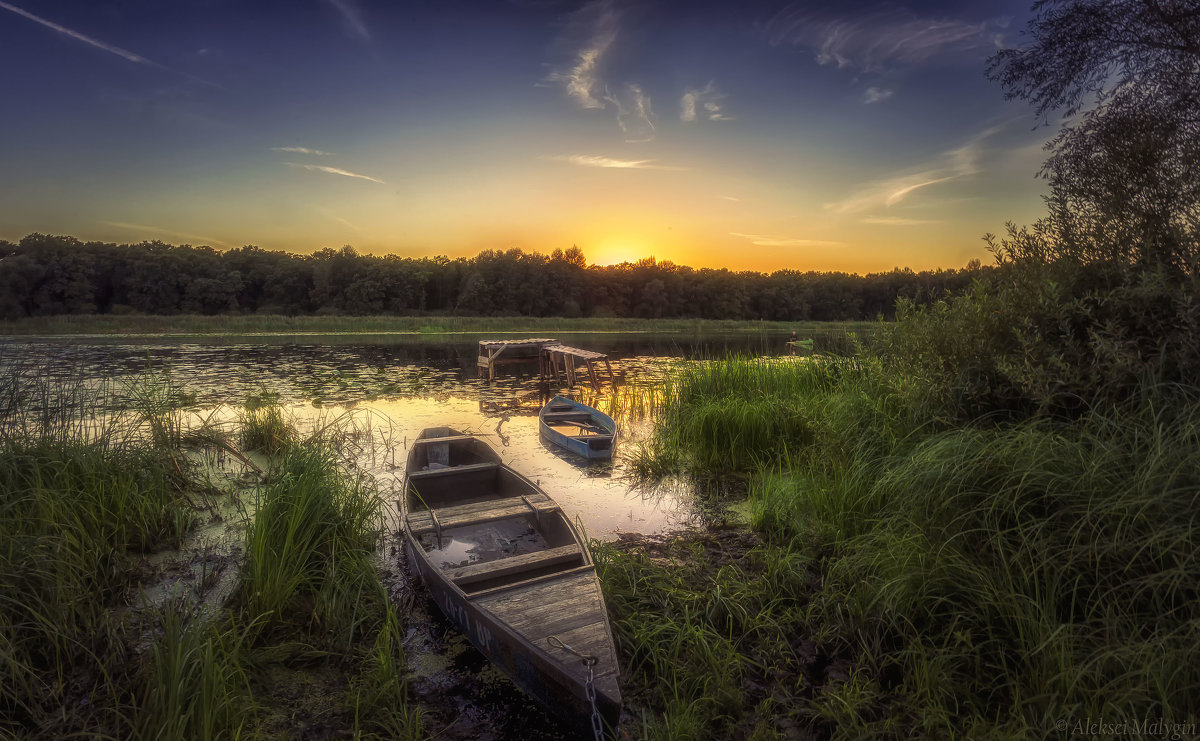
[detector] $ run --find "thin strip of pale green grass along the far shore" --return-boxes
[0,314,878,337]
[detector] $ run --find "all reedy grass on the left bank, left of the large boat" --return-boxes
[0,368,425,740]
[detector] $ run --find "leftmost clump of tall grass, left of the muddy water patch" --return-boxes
[0,374,193,735]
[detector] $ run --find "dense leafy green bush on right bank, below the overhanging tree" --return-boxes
[872,236,1200,421]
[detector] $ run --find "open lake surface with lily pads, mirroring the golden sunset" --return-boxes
[0,335,825,540]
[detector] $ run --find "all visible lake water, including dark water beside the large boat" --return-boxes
[0,329,845,741]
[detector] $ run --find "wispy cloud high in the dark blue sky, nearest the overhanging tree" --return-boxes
[763,6,1007,72]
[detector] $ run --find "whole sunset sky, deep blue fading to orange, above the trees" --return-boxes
[0,0,1052,272]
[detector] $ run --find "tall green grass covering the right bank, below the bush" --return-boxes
[628,361,1200,737]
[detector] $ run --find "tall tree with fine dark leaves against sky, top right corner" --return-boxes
[988,0,1200,271]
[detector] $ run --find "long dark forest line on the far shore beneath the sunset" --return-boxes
[0,234,990,321]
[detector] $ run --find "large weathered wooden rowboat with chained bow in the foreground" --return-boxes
[400,427,620,737]
